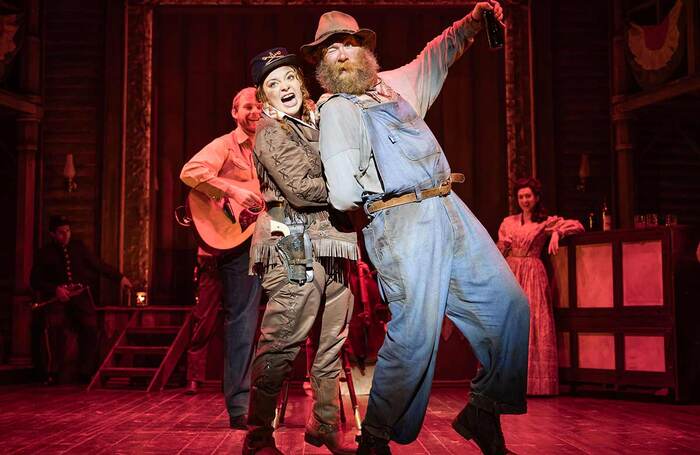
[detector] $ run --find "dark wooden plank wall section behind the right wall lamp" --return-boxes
[540,0,612,225]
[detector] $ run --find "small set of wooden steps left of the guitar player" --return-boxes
[87,306,192,392]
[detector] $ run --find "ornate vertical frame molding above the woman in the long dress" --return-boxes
[504,1,533,211]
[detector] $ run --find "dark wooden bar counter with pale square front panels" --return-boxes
[552,226,700,400]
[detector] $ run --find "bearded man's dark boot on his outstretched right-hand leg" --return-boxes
[452,403,508,455]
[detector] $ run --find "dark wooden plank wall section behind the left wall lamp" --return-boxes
[40,0,105,253]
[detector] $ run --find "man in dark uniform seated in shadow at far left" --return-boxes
[30,216,131,385]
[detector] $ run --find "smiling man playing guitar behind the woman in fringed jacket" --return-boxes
[180,87,263,429]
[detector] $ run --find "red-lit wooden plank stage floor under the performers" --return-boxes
[0,386,700,455]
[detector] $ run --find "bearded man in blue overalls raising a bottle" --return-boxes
[301,1,529,454]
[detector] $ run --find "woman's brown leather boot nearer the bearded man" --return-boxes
[304,376,357,455]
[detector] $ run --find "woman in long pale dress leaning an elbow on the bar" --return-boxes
[498,178,583,395]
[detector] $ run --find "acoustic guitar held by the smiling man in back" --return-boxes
[186,180,263,252]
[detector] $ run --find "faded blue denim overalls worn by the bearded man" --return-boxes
[339,94,530,443]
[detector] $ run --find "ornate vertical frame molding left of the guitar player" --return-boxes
[123,3,153,289]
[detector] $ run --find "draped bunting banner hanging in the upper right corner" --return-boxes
[626,0,686,88]
